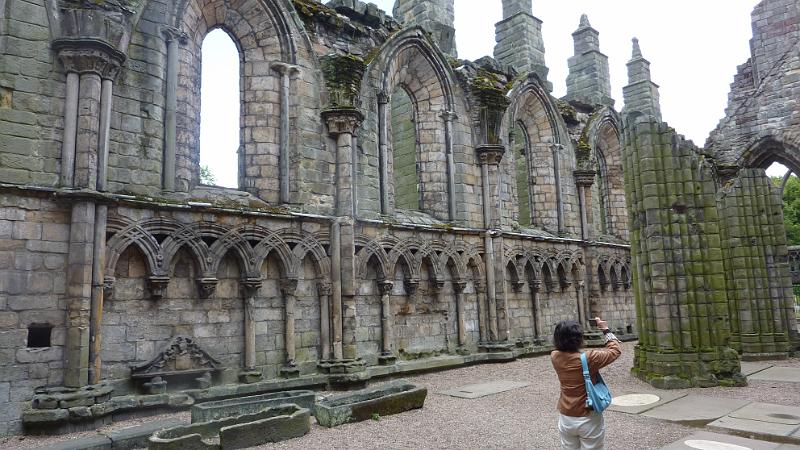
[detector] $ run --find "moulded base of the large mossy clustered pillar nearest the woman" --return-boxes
[631,345,747,389]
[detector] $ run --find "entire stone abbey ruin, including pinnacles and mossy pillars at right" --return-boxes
[0,0,800,435]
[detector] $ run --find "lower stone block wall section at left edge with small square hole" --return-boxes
[0,193,70,435]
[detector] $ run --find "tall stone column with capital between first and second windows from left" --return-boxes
[322,108,364,360]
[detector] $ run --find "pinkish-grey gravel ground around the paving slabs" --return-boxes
[6,343,800,450]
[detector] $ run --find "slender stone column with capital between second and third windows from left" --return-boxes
[478,145,505,342]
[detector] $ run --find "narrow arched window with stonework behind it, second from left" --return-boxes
[391,86,422,211]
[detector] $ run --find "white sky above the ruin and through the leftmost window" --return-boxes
[201,0,785,186]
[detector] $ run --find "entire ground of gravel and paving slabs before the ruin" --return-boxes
[0,343,800,450]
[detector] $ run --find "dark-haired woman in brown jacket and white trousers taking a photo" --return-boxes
[550,317,622,450]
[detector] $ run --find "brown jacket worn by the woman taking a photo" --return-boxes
[550,340,622,417]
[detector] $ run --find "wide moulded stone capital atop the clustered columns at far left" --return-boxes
[53,38,125,80]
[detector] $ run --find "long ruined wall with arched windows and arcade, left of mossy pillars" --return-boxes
[0,0,638,434]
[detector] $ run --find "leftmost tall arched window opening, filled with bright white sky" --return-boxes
[200,28,241,188]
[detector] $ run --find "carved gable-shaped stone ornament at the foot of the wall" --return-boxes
[131,336,220,378]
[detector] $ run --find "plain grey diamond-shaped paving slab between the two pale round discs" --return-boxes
[642,395,750,425]
